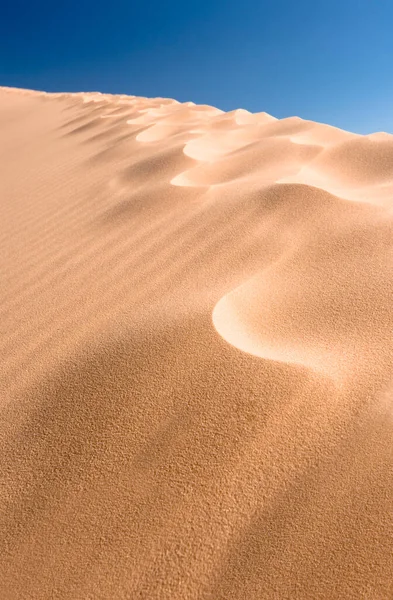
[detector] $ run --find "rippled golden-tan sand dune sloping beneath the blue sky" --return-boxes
[0,88,393,600]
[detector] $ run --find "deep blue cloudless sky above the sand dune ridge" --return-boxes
[0,0,393,133]
